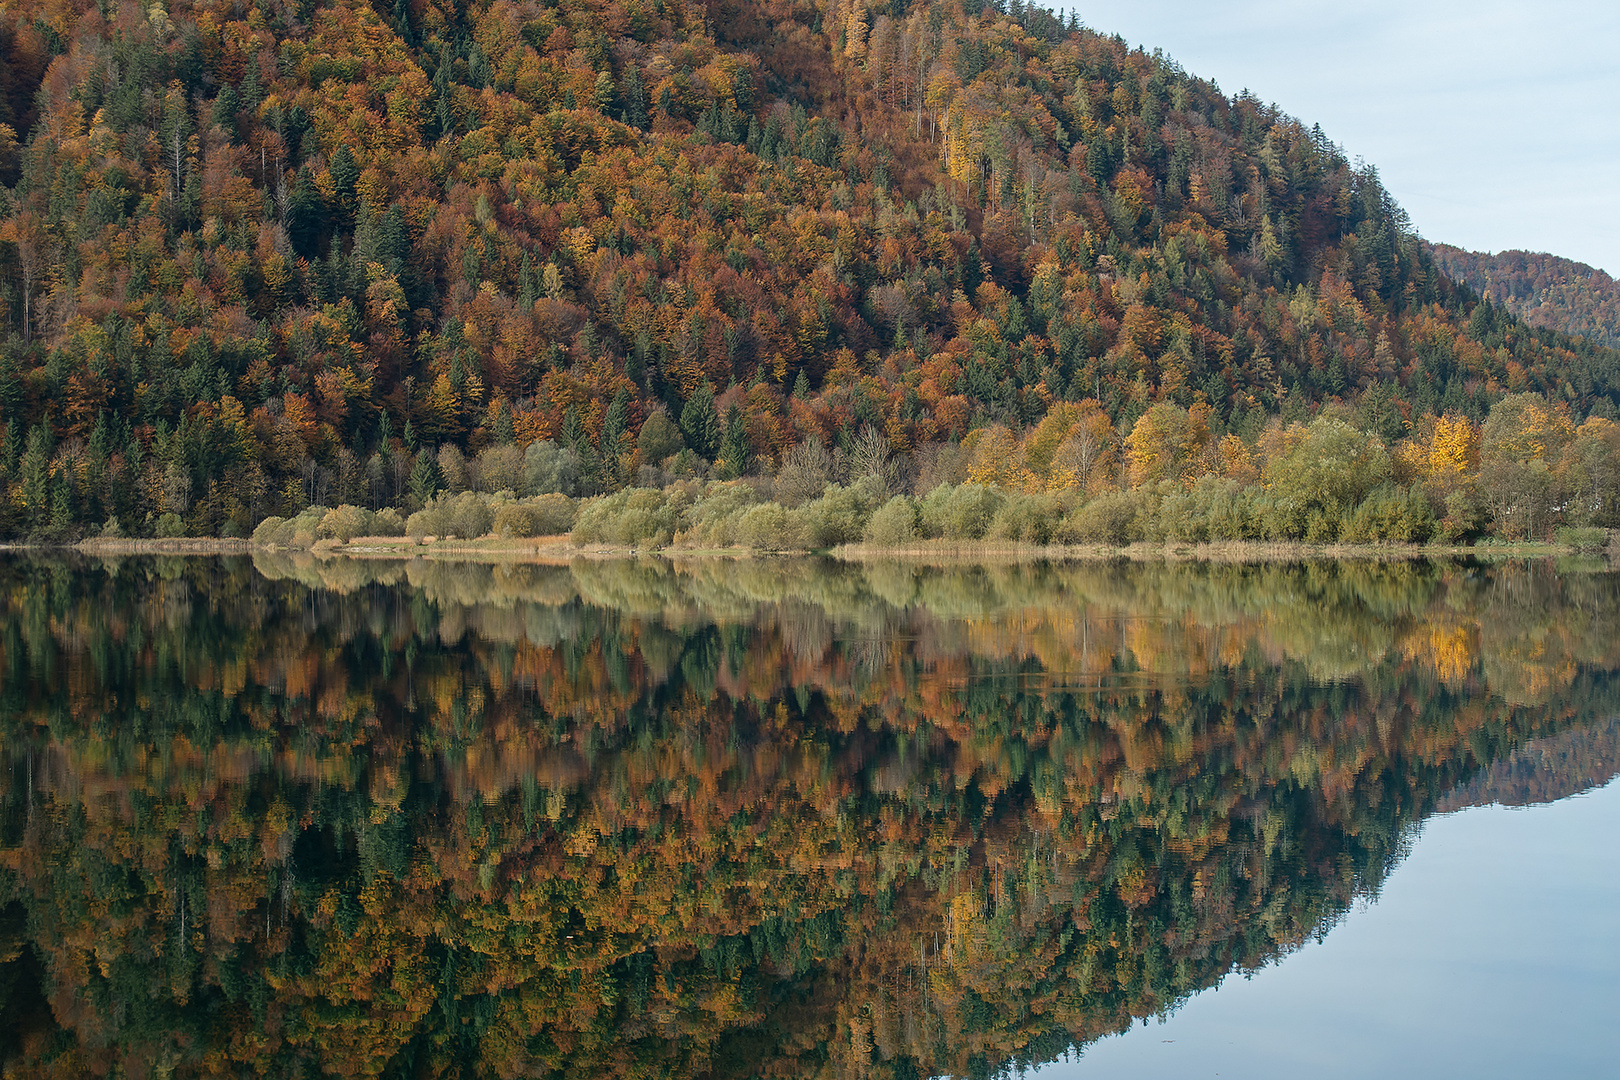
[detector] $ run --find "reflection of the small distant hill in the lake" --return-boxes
[1435,717,1620,813]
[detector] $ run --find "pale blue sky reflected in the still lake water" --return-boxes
[1032,782,1620,1080]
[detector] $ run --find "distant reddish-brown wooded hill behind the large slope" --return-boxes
[1434,244,1620,347]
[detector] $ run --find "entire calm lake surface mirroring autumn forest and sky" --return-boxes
[0,554,1620,1080]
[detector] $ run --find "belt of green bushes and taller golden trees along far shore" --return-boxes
[202,395,1620,563]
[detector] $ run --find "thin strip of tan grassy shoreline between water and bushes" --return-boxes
[34,536,1620,565]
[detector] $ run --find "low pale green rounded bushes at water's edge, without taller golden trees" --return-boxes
[234,478,1612,557]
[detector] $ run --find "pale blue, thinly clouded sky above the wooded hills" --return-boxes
[1058,0,1620,275]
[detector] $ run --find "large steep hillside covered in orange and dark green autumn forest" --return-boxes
[0,0,1620,538]
